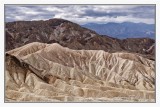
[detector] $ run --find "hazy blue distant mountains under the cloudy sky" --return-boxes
[82,22,155,39]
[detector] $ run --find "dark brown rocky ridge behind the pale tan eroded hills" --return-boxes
[5,19,155,60]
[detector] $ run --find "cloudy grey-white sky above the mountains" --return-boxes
[5,5,155,25]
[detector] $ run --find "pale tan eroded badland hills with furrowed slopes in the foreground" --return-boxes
[5,42,155,102]
